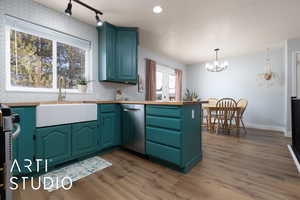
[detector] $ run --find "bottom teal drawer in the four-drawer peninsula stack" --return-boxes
[146,142,181,166]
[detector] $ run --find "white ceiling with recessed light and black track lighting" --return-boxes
[35,0,300,64]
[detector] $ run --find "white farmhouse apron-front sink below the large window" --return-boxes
[36,104,97,127]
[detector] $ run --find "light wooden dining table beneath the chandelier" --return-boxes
[202,103,243,132]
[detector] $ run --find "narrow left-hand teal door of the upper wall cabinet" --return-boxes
[105,25,117,81]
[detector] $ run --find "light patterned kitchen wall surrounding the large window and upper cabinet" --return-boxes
[0,0,184,102]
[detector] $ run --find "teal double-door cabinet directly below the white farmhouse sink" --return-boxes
[36,121,100,166]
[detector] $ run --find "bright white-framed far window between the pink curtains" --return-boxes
[156,65,176,101]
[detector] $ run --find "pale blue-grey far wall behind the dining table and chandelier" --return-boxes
[187,48,285,131]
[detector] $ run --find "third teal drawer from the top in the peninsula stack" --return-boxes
[146,127,181,148]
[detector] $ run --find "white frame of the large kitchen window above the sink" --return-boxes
[5,22,93,93]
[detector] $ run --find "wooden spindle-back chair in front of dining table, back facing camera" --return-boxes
[214,98,237,134]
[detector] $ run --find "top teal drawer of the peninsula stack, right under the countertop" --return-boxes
[146,106,182,118]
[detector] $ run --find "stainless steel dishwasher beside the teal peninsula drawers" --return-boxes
[122,104,145,154]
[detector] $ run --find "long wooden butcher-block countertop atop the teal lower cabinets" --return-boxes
[3,100,207,107]
